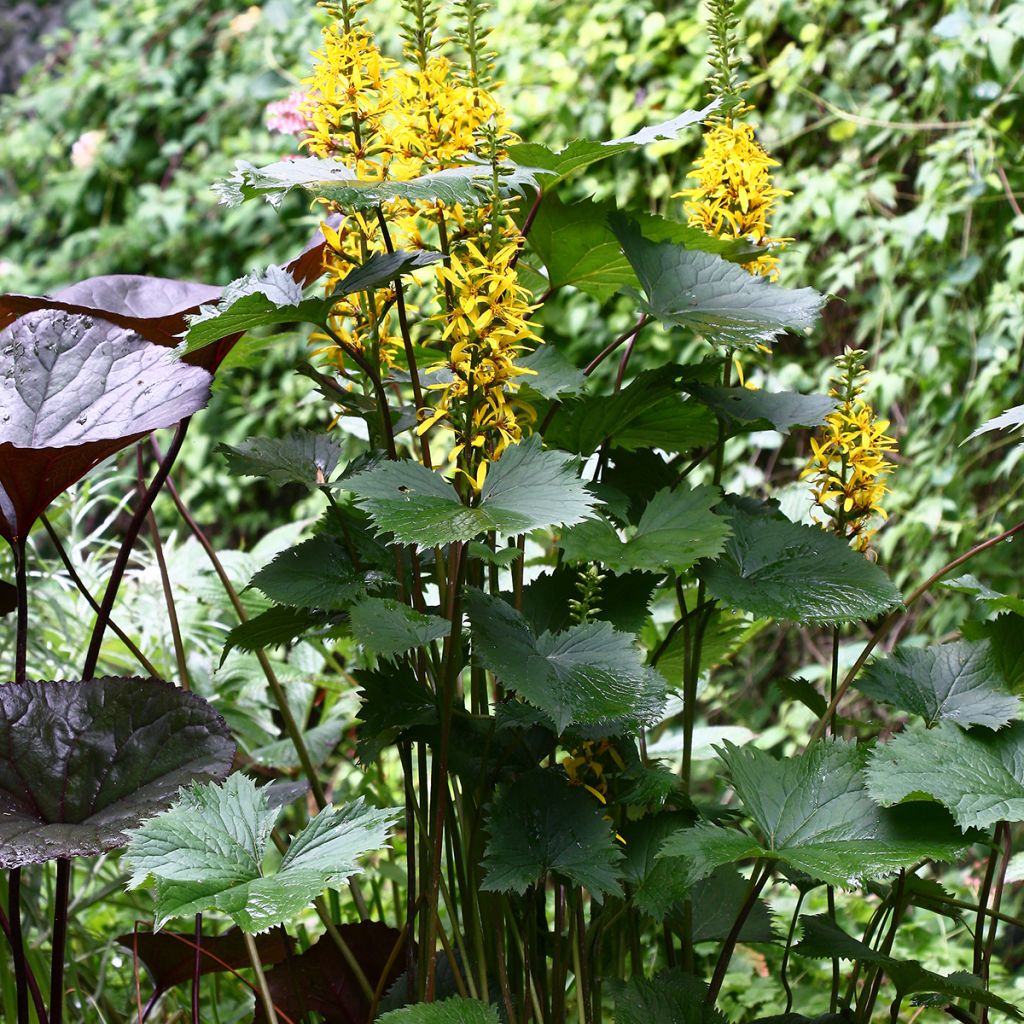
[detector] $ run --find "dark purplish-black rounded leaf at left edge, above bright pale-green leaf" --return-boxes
[0,676,234,868]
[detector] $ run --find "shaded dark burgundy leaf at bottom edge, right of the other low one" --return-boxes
[253,921,406,1024]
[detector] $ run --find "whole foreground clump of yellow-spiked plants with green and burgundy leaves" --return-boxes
[0,0,1024,1024]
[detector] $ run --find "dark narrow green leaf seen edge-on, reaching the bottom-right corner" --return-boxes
[793,914,1024,1020]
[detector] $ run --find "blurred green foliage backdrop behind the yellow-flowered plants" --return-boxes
[0,0,1024,606]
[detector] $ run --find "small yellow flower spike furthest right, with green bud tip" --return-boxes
[801,349,896,551]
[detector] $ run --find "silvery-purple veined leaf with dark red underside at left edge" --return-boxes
[0,309,210,541]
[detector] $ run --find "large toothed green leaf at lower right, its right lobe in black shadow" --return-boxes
[663,740,968,887]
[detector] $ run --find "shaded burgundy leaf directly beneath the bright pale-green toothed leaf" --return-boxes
[117,928,295,992]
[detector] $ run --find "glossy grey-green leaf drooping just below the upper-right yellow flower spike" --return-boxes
[611,216,824,347]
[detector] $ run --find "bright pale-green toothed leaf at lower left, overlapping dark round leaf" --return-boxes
[124,774,400,933]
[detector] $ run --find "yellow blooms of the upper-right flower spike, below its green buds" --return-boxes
[676,108,792,280]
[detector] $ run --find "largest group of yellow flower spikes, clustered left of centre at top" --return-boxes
[292,5,540,477]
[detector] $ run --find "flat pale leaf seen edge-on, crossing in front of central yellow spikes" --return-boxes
[213,157,540,211]
